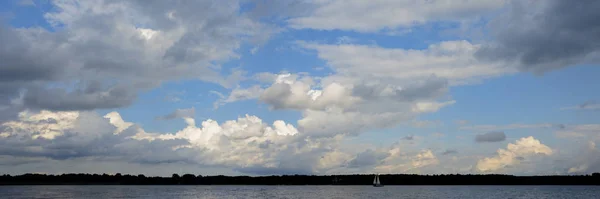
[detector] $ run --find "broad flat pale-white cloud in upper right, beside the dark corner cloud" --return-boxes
[300,41,514,85]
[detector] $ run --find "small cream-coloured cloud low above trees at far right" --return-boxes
[476,136,553,172]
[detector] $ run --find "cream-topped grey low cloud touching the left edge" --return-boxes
[0,111,185,163]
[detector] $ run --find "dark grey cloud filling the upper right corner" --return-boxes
[477,0,600,73]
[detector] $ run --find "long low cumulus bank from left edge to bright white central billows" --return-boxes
[0,111,346,174]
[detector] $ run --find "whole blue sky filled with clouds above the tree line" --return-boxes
[0,0,600,176]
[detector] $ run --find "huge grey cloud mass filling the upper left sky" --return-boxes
[0,0,276,117]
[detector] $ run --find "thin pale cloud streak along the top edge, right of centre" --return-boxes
[287,0,504,32]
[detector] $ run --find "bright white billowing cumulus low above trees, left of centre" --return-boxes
[132,112,342,174]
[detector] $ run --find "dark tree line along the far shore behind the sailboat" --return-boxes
[0,173,600,185]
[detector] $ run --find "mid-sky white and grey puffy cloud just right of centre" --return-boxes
[253,71,455,137]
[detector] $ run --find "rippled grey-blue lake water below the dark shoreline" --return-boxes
[0,186,600,199]
